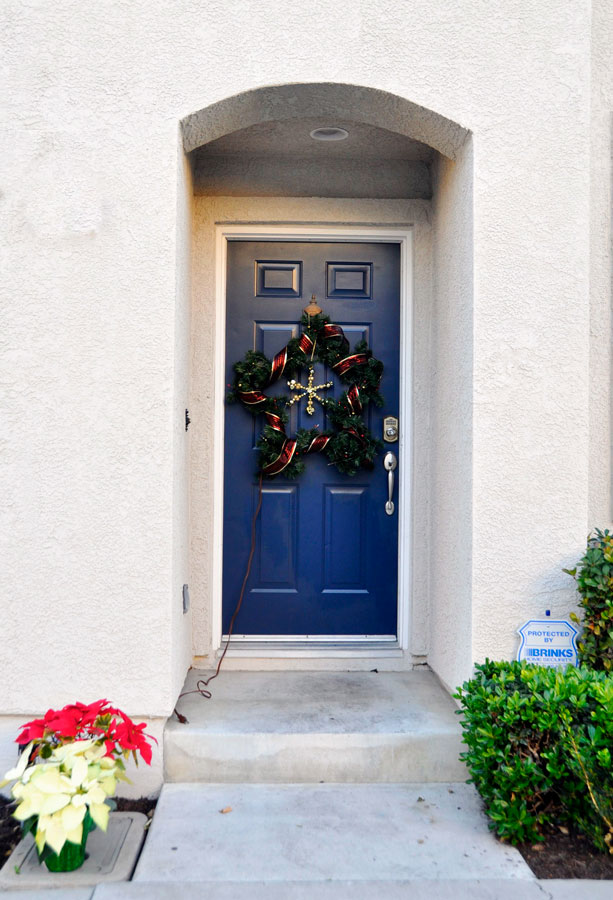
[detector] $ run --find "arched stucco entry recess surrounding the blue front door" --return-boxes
[182,83,472,677]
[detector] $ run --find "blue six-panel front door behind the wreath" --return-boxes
[223,241,400,638]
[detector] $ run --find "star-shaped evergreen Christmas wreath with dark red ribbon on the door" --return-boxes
[228,312,383,478]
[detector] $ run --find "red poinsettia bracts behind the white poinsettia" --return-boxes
[17,700,157,765]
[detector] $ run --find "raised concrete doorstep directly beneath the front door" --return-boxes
[164,670,467,783]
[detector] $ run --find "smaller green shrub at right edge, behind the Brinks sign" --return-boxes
[564,529,613,672]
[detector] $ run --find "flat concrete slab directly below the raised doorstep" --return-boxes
[133,783,534,884]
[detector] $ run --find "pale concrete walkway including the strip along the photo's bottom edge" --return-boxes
[0,783,613,900]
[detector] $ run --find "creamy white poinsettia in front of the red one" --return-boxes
[0,740,127,855]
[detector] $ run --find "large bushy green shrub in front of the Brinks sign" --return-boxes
[455,660,613,852]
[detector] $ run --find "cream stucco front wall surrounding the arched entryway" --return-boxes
[0,0,611,788]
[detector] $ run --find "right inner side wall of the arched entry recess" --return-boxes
[428,141,474,688]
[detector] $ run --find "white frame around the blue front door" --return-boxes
[211,224,413,657]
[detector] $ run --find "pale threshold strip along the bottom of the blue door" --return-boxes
[215,639,404,659]
